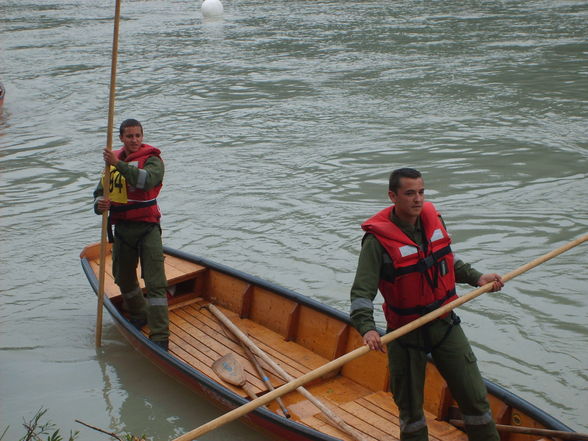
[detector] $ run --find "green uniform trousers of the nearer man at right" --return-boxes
[388,316,499,441]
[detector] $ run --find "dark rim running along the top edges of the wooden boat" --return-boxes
[80,246,573,441]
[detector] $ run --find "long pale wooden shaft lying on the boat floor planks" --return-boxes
[208,303,365,441]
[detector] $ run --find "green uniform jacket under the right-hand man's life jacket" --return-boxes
[351,208,482,335]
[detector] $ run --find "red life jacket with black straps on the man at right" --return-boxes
[361,202,457,329]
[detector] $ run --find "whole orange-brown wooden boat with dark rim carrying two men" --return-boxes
[80,244,571,441]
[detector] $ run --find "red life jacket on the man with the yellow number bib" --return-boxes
[110,144,162,224]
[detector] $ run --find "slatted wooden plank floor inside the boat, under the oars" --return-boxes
[163,300,467,441]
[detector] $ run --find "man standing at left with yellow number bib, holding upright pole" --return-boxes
[94,119,169,351]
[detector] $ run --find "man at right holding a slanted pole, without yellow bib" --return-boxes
[351,168,504,441]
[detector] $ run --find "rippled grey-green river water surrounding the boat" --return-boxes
[0,0,588,441]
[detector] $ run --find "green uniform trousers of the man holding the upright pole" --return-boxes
[112,222,169,341]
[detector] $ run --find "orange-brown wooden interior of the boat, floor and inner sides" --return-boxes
[85,246,552,441]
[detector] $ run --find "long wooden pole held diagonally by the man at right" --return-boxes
[173,234,588,441]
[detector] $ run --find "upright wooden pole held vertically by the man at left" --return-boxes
[96,0,121,348]
